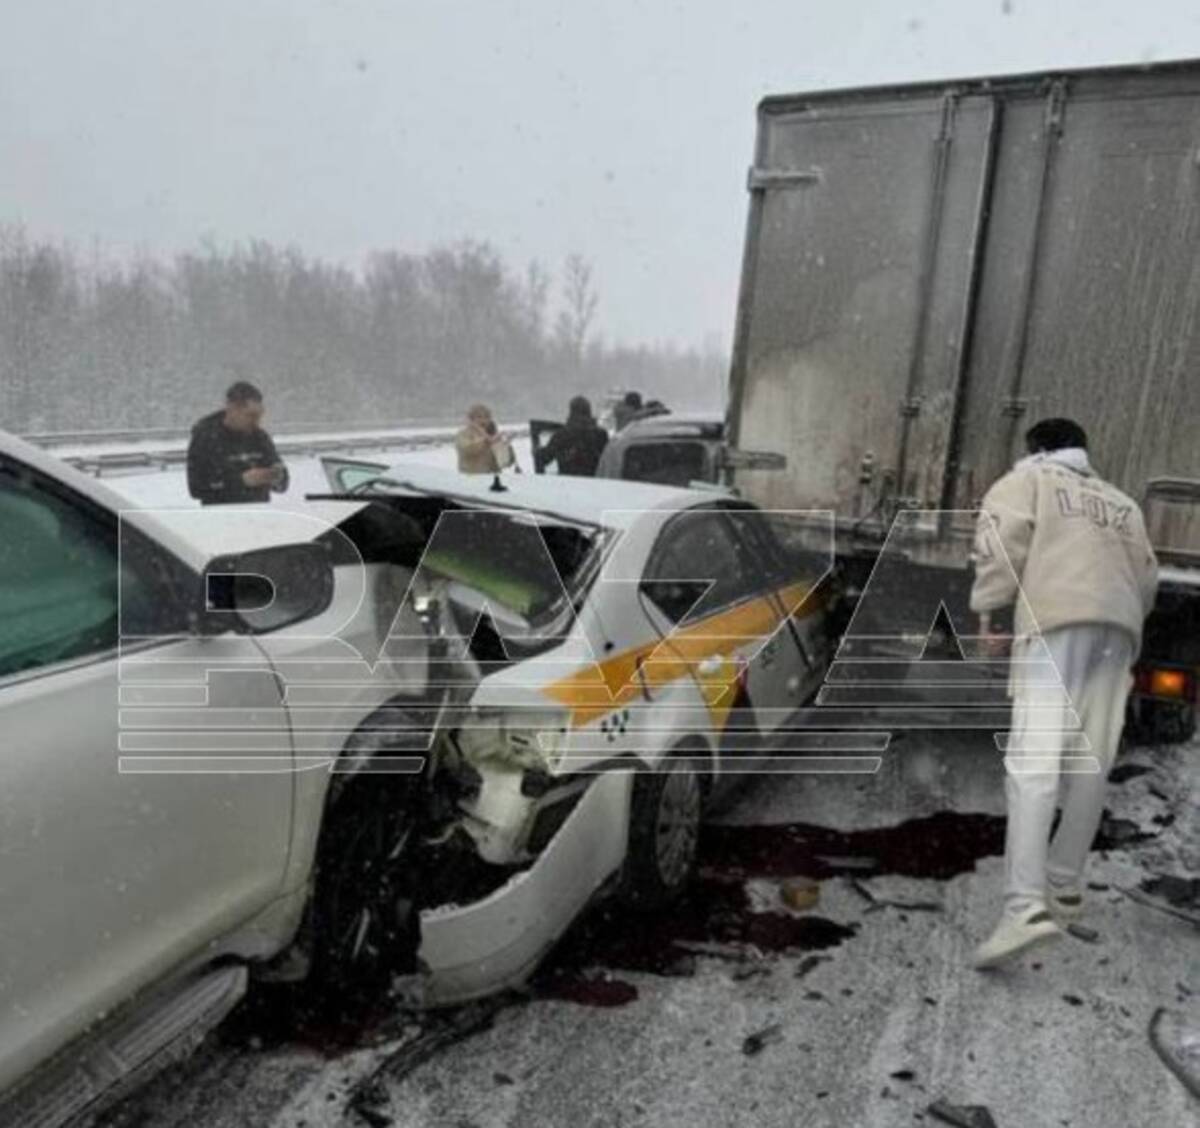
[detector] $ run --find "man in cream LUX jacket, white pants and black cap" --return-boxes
[971,419,1158,967]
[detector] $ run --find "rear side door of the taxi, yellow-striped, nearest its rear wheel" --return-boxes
[643,506,798,751]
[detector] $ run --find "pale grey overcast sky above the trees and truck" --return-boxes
[0,0,1200,343]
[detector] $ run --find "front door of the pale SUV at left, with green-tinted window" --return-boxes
[0,456,292,1088]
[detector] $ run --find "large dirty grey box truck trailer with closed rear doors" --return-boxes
[727,61,1200,737]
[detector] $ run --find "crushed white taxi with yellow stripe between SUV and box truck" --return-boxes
[316,460,830,1003]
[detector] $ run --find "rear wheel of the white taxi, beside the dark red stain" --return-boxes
[622,752,704,911]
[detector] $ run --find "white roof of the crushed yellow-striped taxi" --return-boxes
[369,462,724,528]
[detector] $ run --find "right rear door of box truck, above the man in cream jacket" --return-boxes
[956,79,1200,508]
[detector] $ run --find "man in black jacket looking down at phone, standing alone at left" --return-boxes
[187,380,288,505]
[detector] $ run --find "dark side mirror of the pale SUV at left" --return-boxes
[202,544,334,635]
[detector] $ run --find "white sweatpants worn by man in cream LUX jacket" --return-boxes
[1004,623,1134,913]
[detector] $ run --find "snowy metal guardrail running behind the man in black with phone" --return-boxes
[24,421,529,478]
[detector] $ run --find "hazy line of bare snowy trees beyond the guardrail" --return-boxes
[0,227,726,433]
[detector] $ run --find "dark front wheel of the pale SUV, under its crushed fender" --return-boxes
[313,775,420,1001]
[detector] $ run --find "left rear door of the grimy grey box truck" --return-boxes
[731,91,997,516]
